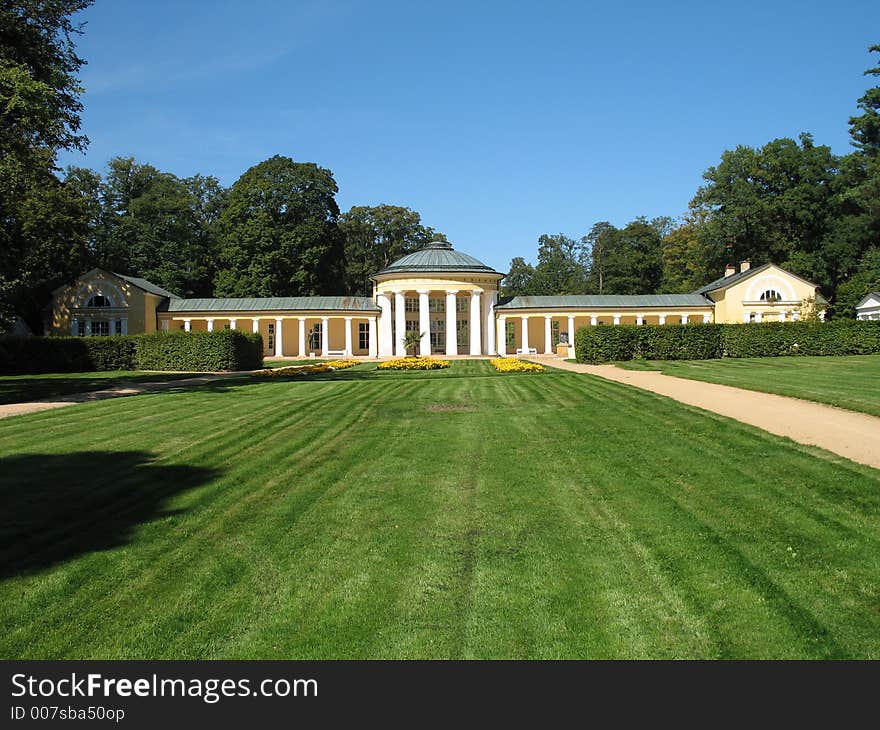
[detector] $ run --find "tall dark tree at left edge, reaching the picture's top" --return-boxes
[0,0,91,331]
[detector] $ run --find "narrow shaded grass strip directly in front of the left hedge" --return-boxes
[0,370,200,405]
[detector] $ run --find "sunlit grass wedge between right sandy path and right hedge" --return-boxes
[618,355,880,416]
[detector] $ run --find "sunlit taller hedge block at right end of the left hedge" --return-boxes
[135,330,263,372]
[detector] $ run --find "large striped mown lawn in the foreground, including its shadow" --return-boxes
[0,361,880,659]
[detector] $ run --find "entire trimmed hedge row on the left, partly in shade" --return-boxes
[0,330,263,374]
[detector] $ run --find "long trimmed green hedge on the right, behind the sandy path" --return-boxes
[575,320,880,363]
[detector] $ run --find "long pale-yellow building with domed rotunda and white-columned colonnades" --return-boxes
[47,241,826,357]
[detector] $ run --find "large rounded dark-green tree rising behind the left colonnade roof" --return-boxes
[215,155,345,297]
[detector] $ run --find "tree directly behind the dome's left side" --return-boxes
[339,205,446,296]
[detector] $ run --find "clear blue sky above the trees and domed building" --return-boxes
[61,0,880,270]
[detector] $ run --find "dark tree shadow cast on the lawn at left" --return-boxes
[0,451,220,578]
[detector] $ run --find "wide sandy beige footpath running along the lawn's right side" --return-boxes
[530,358,880,469]
